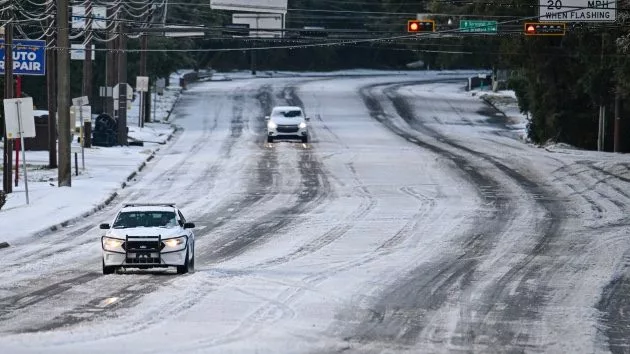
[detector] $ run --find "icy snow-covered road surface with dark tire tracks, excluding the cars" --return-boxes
[0,74,630,353]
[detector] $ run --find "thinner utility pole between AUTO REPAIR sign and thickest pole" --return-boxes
[46,9,57,168]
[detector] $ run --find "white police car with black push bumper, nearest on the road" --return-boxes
[100,203,195,274]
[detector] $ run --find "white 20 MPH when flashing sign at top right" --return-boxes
[538,0,617,22]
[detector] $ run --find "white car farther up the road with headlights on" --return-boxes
[265,106,310,143]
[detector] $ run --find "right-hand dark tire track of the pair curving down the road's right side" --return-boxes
[392,83,568,349]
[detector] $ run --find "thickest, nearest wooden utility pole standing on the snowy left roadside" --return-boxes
[57,0,72,187]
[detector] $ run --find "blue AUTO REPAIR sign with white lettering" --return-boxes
[0,39,46,75]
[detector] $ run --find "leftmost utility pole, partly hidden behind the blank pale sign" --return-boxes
[2,20,13,193]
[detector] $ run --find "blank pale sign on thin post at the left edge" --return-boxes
[4,97,35,204]
